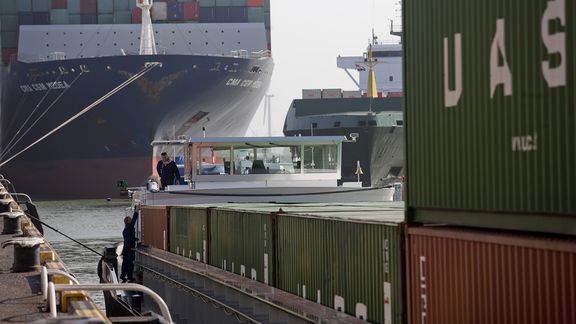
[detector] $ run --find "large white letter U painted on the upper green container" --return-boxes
[444,33,462,107]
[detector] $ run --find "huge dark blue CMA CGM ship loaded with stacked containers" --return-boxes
[0,0,273,199]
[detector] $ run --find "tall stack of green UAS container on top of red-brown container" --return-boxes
[403,0,576,323]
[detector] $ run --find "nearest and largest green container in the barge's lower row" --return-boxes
[275,215,405,323]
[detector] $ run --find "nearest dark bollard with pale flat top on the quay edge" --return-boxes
[2,237,44,272]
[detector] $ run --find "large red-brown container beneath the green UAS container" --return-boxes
[406,226,576,324]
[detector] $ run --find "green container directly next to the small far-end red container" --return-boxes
[170,207,208,263]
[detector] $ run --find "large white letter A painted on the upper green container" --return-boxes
[490,19,512,98]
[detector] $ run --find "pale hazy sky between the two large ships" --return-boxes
[246,0,401,136]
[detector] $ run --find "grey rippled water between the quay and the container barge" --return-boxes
[36,199,130,309]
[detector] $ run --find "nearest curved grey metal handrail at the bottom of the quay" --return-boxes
[48,282,174,323]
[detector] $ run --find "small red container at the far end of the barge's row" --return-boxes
[140,206,170,251]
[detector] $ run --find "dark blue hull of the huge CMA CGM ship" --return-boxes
[0,55,273,199]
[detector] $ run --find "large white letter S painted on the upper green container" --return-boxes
[541,0,566,88]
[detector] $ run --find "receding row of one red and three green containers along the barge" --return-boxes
[140,202,406,323]
